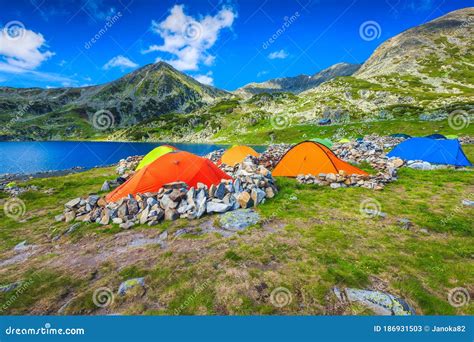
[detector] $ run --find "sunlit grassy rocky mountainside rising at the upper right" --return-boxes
[300,7,474,117]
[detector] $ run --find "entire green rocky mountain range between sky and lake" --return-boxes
[0,7,474,142]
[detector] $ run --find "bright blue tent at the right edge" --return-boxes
[387,138,472,166]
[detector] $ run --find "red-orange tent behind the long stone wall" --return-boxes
[105,152,232,202]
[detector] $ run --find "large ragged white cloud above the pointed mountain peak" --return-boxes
[144,5,237,71]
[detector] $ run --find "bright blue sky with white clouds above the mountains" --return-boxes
[0,0,473,90]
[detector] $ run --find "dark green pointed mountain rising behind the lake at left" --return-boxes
[0,62,227,139]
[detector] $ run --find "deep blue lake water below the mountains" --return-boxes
[0,141,264,174]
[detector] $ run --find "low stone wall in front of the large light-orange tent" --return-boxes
[296,170,396,190]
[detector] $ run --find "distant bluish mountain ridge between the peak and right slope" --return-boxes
[233,63,360,99]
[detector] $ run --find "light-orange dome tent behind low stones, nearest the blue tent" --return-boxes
[272,141,368,177]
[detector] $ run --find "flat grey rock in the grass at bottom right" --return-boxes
[333,288,415,316]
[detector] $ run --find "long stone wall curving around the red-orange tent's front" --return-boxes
[56,161,277,229]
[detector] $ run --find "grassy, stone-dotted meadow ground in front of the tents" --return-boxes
[0,145,474,315]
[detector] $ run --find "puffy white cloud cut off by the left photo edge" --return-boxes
[0,29,54,73]
